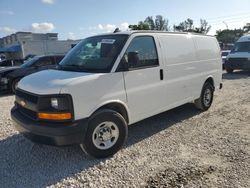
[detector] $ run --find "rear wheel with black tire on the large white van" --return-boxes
[194,82,214,111]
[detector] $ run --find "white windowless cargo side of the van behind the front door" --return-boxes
[158,34,222,108]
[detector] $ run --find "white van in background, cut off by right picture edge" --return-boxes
[224,35,250,73]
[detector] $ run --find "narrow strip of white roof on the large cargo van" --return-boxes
[94,30,215,37]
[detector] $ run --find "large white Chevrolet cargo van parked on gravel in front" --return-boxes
[11,31,222,158]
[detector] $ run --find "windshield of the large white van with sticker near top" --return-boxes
[58,35,128,73]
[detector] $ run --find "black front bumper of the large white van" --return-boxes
[11,107,88,146]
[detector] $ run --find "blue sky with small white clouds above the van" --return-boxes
[0,0,250,40]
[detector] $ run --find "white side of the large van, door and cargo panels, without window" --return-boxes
[121,33,222,123]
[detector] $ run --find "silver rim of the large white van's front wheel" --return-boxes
[92,121,119,150]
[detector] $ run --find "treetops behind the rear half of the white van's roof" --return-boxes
[174,18,211,34]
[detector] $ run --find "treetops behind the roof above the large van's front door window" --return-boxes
[129,15,169,31]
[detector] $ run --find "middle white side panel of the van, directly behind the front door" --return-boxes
[158,34,201,108]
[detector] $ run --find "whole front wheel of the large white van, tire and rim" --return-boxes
[80,109,128,158]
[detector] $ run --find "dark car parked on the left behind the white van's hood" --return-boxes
[0,55,64,93]
